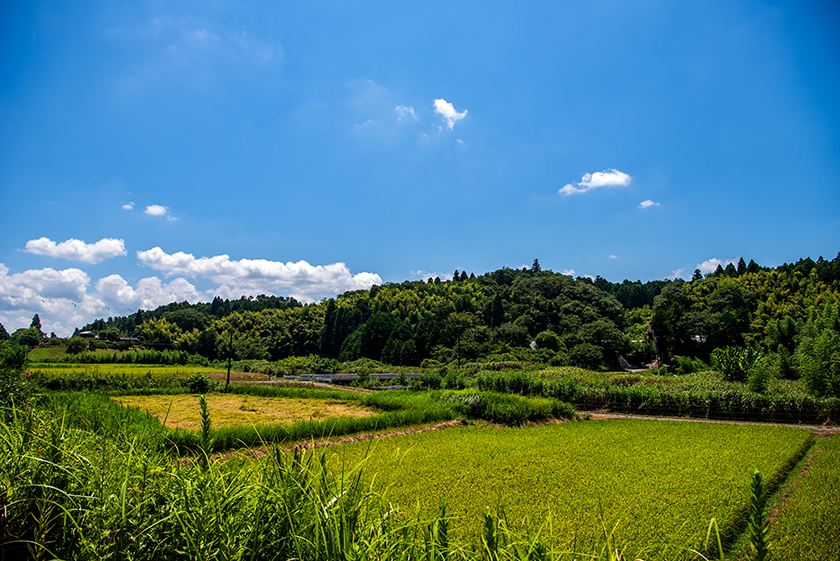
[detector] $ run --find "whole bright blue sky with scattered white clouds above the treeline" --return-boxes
[0,0,840,335]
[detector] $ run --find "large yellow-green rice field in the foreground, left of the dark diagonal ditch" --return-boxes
[331,420,812,559]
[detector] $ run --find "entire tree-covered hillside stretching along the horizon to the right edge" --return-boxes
[60,255,840,384]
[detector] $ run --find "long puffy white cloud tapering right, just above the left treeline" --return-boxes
[137,247,382,300]
